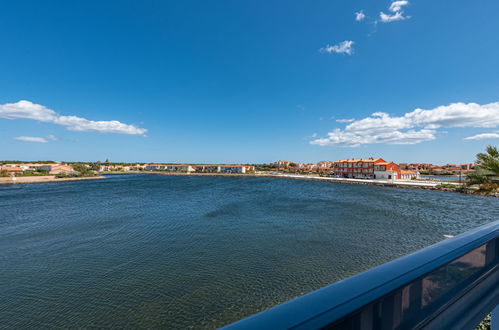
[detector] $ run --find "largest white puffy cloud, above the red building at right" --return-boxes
[311,102,499,147]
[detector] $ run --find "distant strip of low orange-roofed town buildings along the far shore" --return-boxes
[0,157,475,180]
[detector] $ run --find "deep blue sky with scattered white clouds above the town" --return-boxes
[0,0,499,164]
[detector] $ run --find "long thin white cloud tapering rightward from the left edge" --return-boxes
[0,101,147,135]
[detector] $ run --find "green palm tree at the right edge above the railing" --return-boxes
[468,146,499,188]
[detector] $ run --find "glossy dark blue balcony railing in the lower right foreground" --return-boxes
[227,221,499,330]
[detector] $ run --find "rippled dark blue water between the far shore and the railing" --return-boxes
[0,175,499,329]
